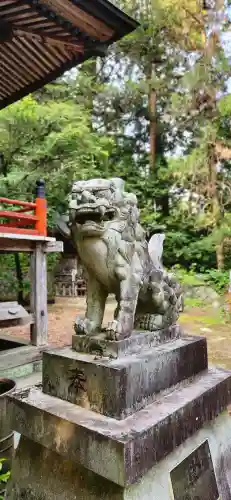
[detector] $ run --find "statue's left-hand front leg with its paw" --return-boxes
[74,277,108,335]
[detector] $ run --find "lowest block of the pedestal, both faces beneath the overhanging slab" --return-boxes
[7,412,231,500]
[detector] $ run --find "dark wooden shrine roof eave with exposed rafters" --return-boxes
[0,0,137,109]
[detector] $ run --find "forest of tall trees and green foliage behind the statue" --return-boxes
[0,0,231,296]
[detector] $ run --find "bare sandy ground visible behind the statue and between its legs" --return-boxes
[3,298,231,369]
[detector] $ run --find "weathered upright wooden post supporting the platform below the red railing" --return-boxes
[30,244,48,346]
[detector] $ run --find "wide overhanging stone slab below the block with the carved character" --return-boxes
[6,369,231,486]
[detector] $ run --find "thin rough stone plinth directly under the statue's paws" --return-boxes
[72,325,181,358]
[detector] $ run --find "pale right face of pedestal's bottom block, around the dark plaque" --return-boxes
[125,411,231,500]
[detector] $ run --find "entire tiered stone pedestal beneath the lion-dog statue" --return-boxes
[7,327,231,500]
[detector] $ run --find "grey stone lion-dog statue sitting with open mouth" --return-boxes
[59,178,182,340]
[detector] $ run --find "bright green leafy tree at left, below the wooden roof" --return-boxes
[0,96,113,225]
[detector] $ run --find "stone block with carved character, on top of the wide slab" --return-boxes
[43,337,207,419]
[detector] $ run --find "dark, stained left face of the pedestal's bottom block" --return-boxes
[7,437,124,500]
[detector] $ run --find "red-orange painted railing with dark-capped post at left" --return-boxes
[0,180,47,236]
